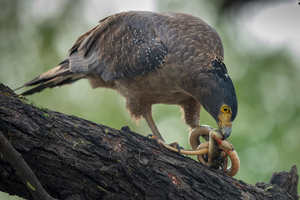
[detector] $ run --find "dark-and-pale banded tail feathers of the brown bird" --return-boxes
[15,59,85,95]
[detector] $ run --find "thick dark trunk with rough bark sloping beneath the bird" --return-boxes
[0,84,299,199]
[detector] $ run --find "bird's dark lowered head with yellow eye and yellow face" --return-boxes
[193,59,237,139]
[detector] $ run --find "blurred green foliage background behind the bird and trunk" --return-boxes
[0,0,300,199]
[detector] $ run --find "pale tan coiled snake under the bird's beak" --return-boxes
[158,125,240,176]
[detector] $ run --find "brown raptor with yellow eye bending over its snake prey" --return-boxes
[18,11,237,150]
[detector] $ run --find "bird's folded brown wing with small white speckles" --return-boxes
[69,12,168,81]
